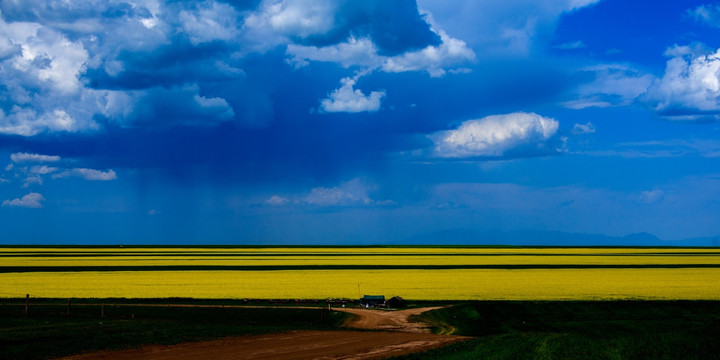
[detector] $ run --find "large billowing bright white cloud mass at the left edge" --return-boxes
[0,13,114,136]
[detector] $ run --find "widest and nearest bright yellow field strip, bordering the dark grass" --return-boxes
[0,268,720,300]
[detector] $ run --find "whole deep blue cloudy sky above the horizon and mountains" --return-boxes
[0,0,720,244]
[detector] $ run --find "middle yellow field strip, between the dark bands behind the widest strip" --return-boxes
[0,255,720,267]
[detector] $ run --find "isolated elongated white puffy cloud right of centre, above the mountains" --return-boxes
[430,112,559,158]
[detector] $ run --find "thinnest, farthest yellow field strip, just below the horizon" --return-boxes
[0,247,720,255]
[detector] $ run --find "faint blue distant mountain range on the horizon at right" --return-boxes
[398,229,720,246]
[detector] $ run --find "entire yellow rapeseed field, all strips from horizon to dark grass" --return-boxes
[0,247,720,300]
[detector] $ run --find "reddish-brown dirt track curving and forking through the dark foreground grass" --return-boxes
[56,308,467,360]
